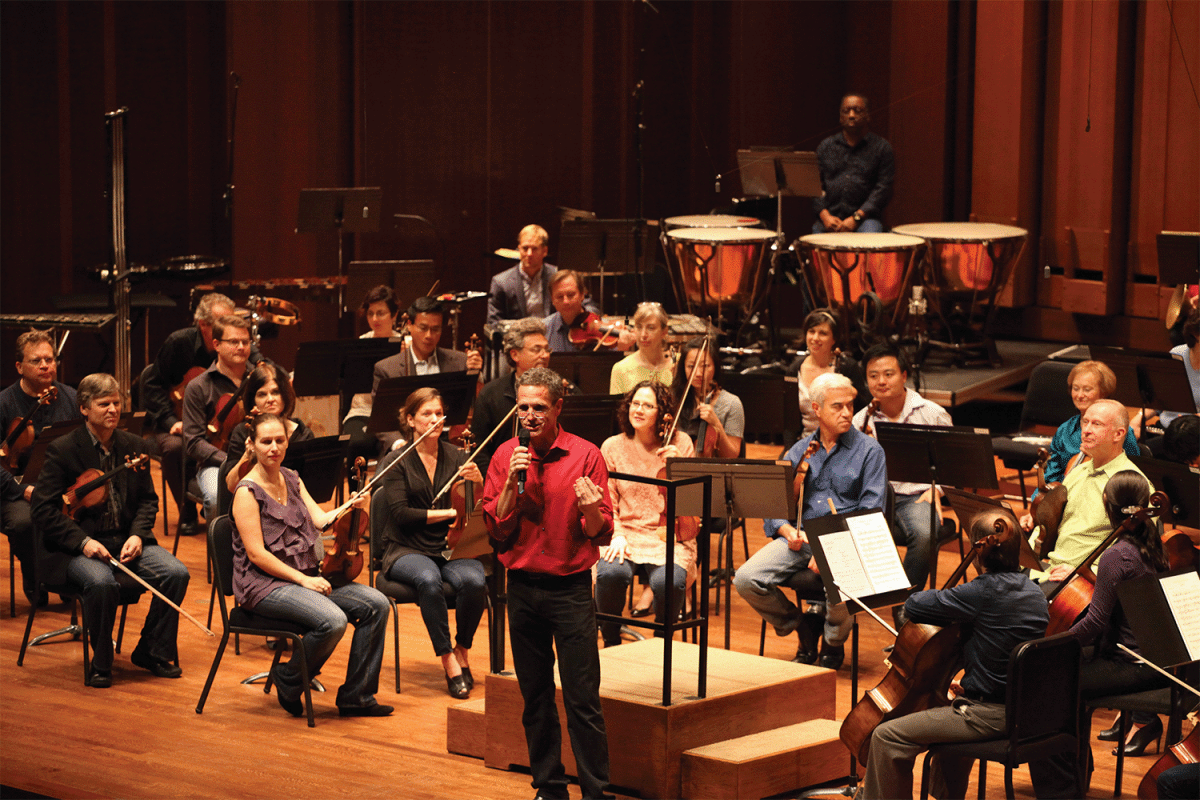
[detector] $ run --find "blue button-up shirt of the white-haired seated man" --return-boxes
[762,428,888,537]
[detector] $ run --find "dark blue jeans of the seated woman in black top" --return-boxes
[388,553,487,656]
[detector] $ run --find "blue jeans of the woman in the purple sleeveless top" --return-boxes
[253,583,390,708]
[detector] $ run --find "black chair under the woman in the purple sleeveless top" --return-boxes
[196,515,317,728]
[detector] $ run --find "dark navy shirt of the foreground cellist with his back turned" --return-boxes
[904,572,1050,702]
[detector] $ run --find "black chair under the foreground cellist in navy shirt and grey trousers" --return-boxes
[920,633,1085,800]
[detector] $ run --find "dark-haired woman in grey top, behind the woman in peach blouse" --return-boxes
[671,336,746,458]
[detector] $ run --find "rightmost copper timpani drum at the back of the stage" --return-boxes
[894,222,1028,344]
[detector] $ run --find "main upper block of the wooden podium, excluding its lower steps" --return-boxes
[472,639,830,798]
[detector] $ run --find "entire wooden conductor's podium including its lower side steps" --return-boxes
[446,638,850,798]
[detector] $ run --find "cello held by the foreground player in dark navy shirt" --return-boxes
[839,515,1019,766]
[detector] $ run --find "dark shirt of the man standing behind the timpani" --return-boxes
[812,132,896,219]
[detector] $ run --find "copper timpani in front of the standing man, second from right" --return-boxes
[799,231,925,343]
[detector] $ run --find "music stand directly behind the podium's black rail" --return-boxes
[667,458,796,650]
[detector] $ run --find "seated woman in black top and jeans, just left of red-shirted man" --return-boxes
[382,389,482,700]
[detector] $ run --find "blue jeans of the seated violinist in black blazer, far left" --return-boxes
[67,545,191,672]
